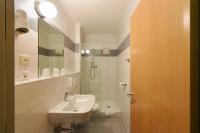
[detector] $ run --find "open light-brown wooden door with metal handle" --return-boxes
[131,0,190,133]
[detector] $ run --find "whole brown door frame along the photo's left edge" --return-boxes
[0,0,15,133]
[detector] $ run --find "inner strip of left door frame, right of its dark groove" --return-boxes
[5,0,15,133]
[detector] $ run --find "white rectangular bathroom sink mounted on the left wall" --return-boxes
[48,95,95,124]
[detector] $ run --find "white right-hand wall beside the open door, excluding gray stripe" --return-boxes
[117,0,140,133]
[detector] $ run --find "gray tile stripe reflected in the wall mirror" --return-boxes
[38,47,64,56]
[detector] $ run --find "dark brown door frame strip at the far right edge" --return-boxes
[190,0,200,133]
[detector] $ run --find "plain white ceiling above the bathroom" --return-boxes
[59,0,130,34]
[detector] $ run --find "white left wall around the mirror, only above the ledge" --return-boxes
[15,0,80,78]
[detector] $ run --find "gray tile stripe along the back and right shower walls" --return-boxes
[82,34,130,57]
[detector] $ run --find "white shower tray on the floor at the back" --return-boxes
[92,100,121,117]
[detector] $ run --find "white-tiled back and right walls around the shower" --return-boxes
[81,32,130,133]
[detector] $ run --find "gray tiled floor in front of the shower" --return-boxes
[77,118,125,133]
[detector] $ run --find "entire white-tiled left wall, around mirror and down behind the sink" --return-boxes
[15,0,80,133]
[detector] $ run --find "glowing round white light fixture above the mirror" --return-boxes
[35,0,57,18]
